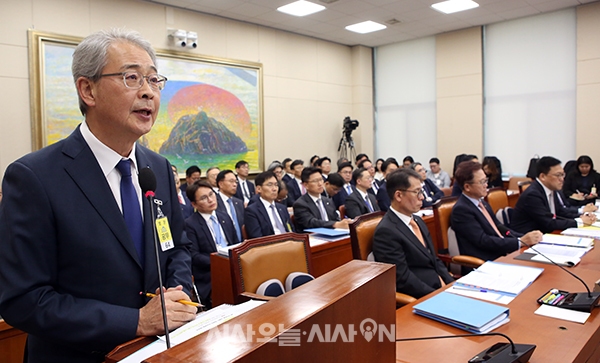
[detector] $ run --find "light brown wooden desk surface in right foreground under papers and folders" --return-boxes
[396,246,600,363]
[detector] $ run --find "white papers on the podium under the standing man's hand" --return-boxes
[119,300,265,363]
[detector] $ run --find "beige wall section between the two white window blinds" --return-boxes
[435,27,483,174]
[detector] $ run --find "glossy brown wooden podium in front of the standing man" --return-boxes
[115,260,396,363]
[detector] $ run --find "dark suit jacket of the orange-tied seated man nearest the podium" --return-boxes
[373,210,453,298]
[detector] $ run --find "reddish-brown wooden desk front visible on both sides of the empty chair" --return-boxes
[210,237,352,306]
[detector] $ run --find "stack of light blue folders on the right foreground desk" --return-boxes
[413,292,510,334]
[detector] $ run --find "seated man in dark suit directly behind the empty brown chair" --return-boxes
[244,171,294,238]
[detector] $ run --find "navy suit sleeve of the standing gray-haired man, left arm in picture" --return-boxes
[0,162,138,351]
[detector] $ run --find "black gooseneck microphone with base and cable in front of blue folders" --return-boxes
[396,333,536,363]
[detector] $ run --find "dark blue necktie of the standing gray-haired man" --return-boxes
[117,159,145,267]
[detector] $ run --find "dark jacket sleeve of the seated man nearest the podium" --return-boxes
[373,224,435,298]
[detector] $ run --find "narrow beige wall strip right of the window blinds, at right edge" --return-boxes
[576,3,600,165]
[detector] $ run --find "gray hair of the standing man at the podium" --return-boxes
[71,28,156,115]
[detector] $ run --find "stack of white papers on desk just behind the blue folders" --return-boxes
[454,261,544,296]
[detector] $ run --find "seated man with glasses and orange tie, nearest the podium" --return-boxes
[373,168,452,298]
